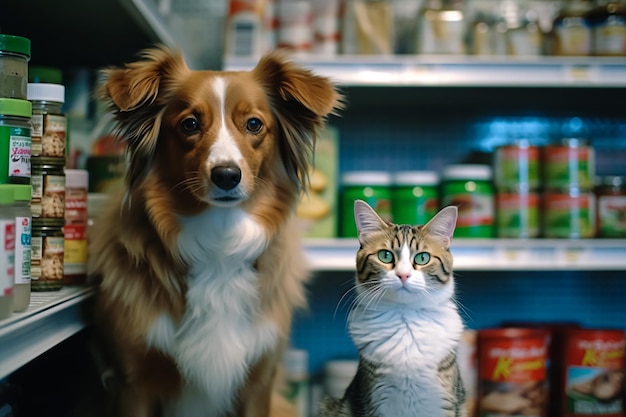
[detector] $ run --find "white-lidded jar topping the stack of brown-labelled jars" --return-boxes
[28,83,67,159]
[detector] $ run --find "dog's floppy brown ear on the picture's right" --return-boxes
[253,51,343,187]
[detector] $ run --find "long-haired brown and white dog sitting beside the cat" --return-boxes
[89,47,341,417]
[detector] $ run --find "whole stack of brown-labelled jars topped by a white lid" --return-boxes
[28,83,67,291]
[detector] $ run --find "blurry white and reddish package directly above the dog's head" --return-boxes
[226,0,278,57]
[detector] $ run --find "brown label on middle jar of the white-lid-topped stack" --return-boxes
[31,175,65,219]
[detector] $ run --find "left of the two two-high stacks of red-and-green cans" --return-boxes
[494,140,540,238]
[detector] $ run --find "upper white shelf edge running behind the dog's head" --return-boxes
[224,55,626,87]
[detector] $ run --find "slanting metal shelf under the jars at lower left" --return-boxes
[0,287,92,378]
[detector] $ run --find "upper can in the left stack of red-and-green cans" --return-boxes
[494,140,540,190]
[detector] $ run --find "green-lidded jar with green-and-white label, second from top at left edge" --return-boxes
[0,98,32,184]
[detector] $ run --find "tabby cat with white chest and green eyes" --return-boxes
[318,200,467,417]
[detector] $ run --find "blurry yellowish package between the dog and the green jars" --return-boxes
[297,126,339,238]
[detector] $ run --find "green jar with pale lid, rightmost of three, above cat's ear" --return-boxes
[441,164,495,238]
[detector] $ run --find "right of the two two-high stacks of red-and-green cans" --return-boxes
[543,138,596,238]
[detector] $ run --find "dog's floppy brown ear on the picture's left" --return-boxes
[96,46,189,188]
